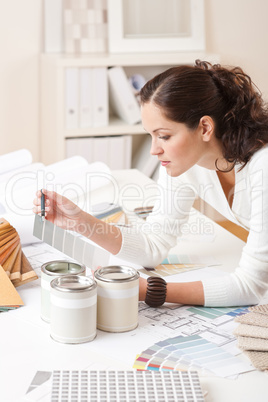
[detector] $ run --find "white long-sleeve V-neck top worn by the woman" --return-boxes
[117,146,268,306]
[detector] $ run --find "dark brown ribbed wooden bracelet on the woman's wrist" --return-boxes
[145,276,167,307]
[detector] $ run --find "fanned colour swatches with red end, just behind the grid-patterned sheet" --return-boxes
[133,335,253,377]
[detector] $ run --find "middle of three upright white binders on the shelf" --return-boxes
[79,68,94,128]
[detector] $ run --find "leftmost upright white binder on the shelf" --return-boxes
[65,68,79,130]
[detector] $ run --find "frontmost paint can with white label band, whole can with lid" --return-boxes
[50,275,97,343]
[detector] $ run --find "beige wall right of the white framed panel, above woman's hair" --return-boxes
[205,0,268,101]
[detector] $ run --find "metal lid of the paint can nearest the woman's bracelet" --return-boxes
[94,265,140,283]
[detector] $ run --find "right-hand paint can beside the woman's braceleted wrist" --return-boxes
[94,265,140,332]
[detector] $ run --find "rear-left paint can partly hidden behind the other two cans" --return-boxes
[41,260,86,322]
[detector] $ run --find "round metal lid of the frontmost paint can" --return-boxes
[50,275,97,292]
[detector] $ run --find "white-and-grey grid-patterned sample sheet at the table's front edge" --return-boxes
[51,370,204,402]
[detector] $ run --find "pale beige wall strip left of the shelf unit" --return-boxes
[0,0,42,160]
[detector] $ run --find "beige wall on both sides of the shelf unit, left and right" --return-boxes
[0,0,268,160]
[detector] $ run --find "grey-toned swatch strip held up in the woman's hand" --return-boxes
[33,215,110,269]
